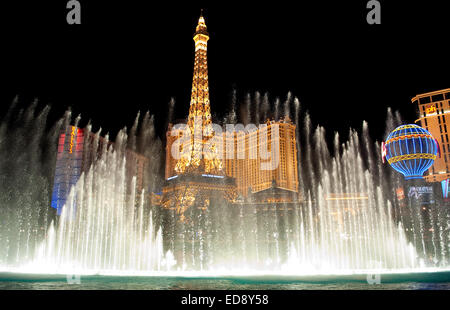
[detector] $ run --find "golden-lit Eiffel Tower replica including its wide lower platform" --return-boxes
[161,14,237,222]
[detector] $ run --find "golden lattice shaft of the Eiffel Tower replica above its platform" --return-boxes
[175,14,222,173]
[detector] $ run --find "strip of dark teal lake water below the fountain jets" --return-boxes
[0,272,450,290]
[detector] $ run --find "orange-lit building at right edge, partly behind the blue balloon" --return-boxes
[411,88,450,182]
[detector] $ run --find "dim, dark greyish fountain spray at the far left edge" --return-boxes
[0,98,70,266]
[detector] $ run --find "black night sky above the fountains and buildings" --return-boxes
[0,0,450,139]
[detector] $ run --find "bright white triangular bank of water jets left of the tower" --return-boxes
[31,126,164,273]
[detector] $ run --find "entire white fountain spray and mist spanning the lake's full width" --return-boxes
[0,92,450,274]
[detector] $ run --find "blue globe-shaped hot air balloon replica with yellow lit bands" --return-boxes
[382,124,439,180]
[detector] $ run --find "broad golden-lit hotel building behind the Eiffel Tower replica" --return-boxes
[165,119,298,197]
